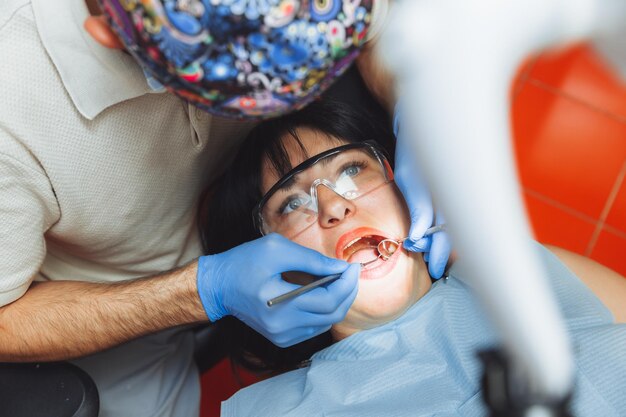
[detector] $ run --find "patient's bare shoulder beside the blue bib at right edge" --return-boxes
[546,246,626,323]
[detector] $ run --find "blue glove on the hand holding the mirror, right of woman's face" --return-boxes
[393,104,451,279]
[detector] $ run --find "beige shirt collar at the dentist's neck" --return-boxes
[32,0,158,120]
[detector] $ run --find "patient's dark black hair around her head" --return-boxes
[198,99,395,373]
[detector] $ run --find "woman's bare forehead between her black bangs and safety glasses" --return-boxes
[261,127,347,194]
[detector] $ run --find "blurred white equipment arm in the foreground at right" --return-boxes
[381,0,626,415]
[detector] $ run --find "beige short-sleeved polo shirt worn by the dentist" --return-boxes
[0,0,251,417]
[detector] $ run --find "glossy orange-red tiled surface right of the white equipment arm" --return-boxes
[512,45,626,275]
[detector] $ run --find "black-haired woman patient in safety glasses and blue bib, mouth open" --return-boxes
[201,102,626,416]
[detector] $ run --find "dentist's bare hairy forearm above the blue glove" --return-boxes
[0,262,207,362]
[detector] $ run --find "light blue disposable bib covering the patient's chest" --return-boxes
[222,245,626,417]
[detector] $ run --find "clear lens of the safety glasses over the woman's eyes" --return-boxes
[261,148,387,235]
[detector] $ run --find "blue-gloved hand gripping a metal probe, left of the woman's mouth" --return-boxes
[197,234,360,347]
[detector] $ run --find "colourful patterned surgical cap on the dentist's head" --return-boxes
[100,0,374,119]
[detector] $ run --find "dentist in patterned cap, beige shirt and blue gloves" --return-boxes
[0,0,448,416]
